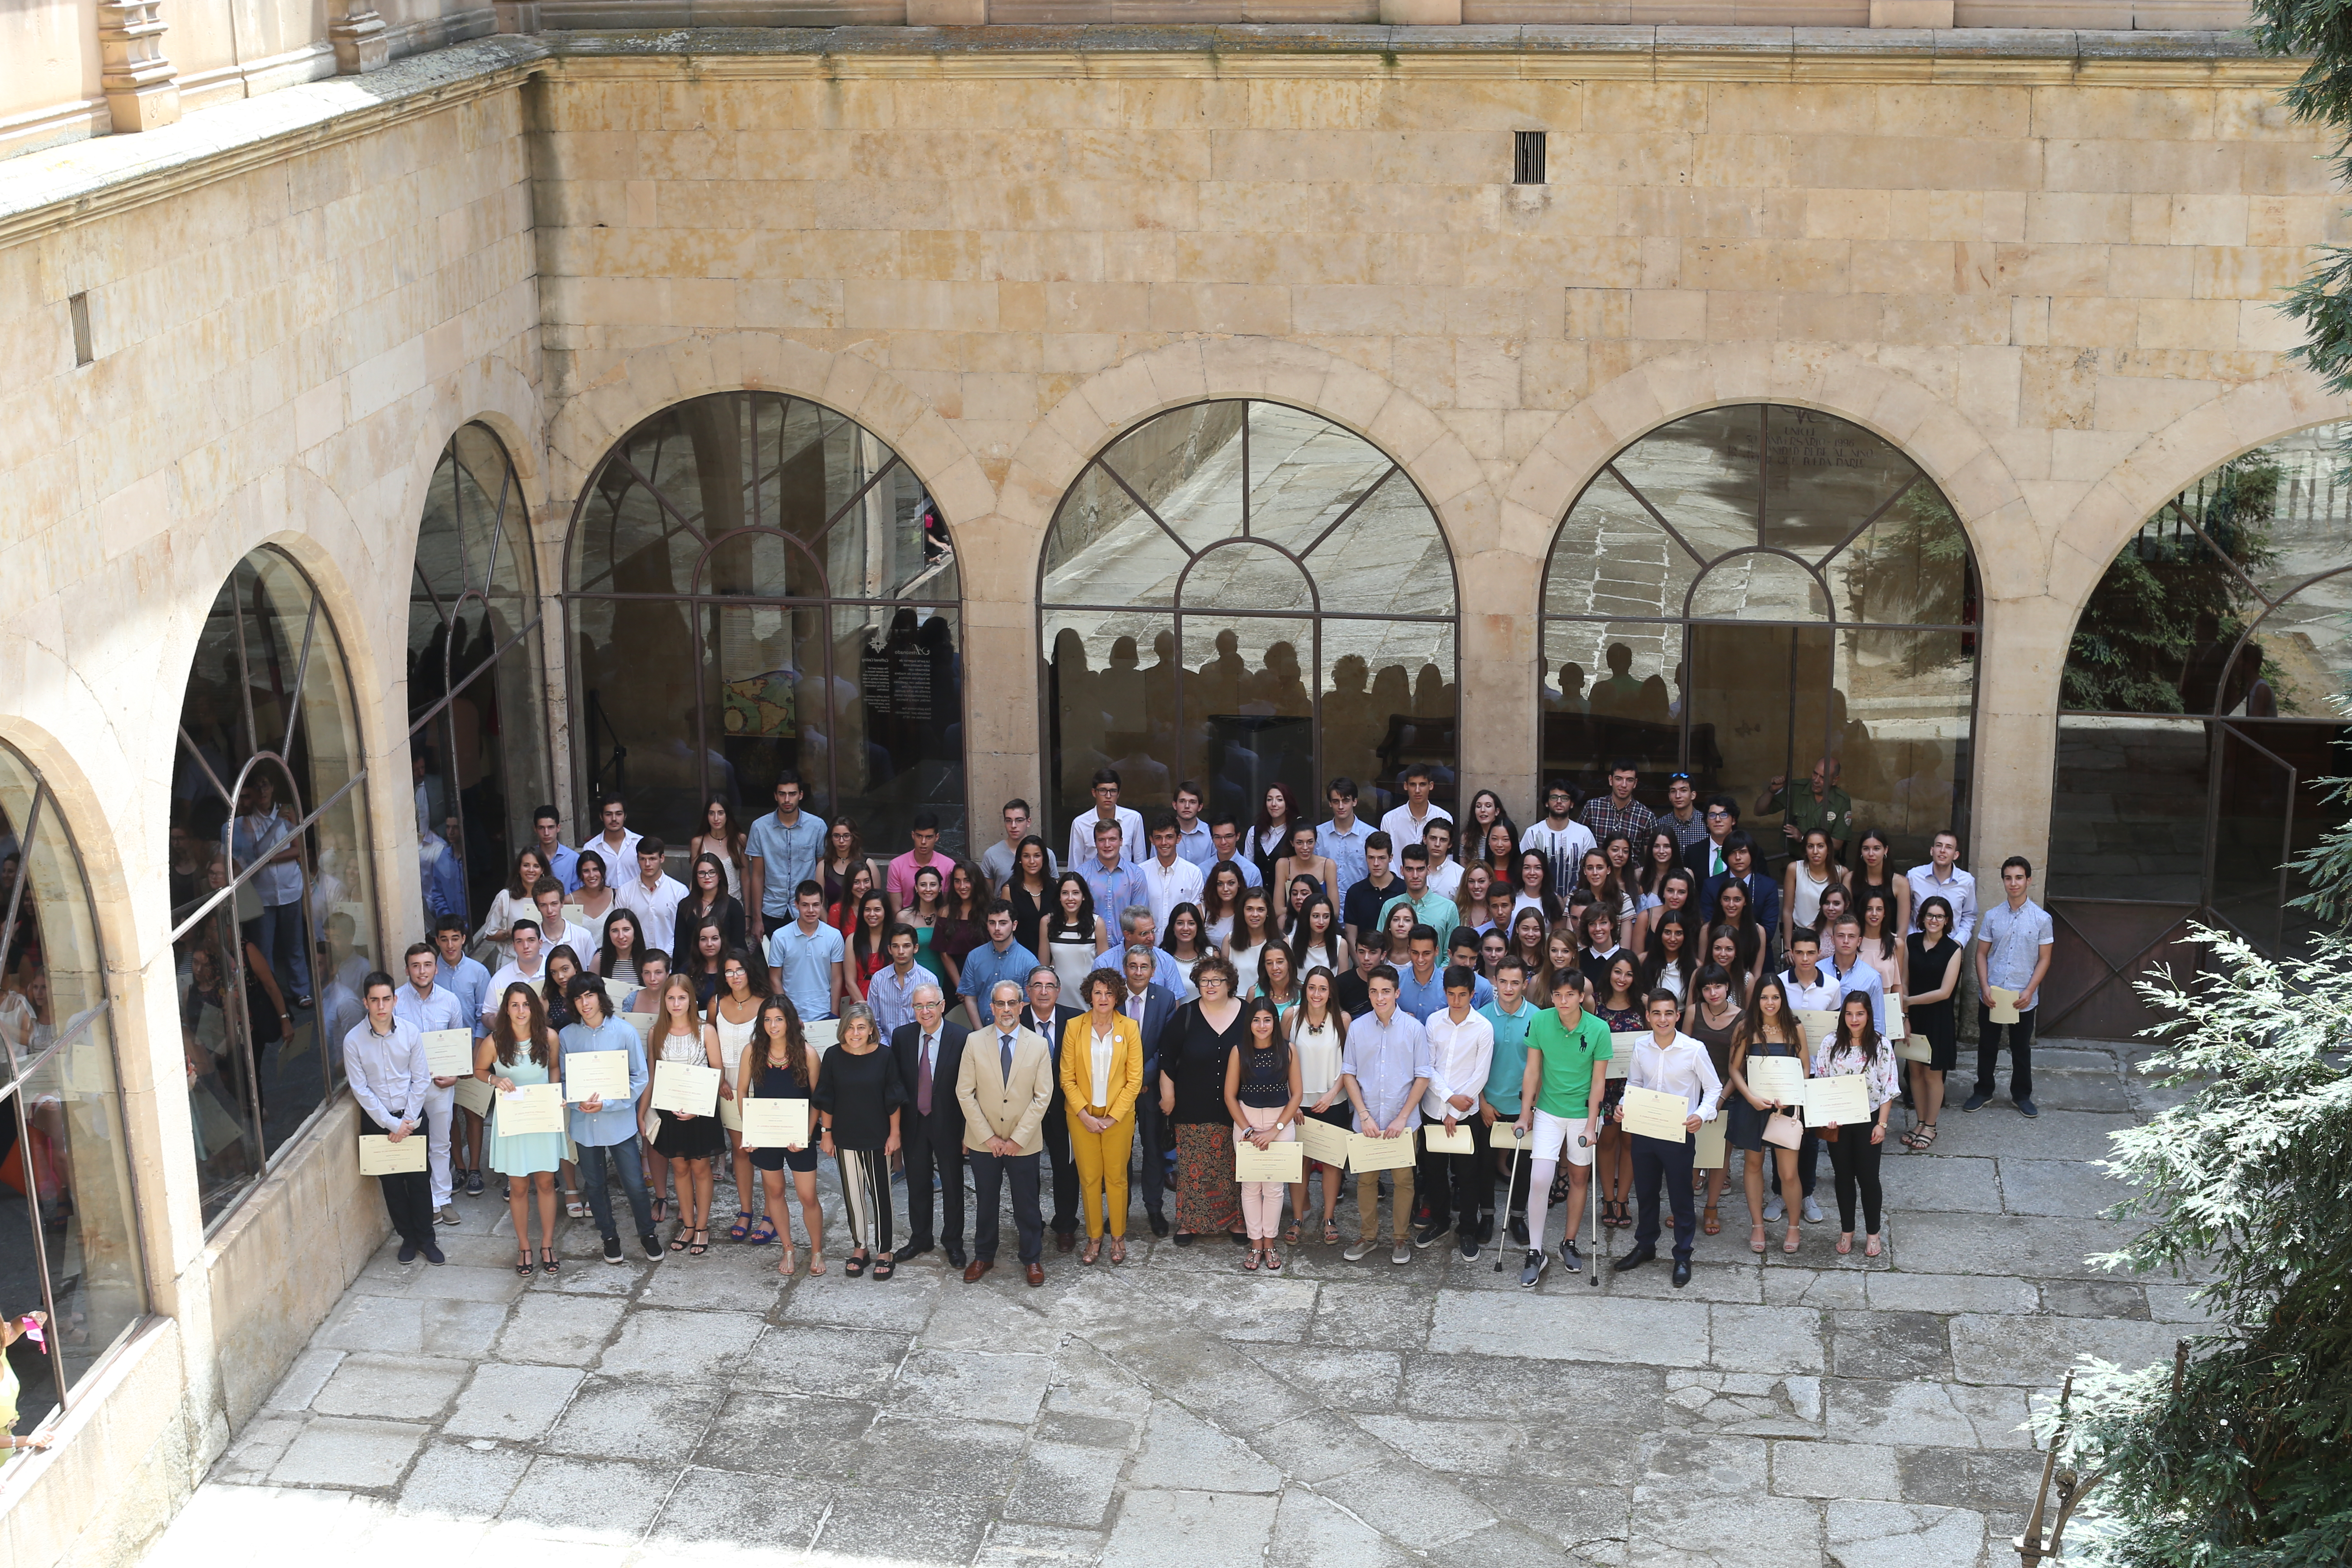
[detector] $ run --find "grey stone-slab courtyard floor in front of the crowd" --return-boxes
[146,1041,2201,1568]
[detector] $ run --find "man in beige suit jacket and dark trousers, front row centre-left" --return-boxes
[955,980,1054,1286]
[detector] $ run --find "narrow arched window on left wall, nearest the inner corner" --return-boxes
[409,426,553,919]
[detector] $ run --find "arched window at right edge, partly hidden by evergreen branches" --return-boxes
[2044,426,2352,1037]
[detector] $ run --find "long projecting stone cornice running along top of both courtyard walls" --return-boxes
[0,26,2300,247]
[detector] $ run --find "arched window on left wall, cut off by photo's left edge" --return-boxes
[0,745,146,1431]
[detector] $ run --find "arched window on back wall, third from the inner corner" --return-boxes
[1538,404,1978,870]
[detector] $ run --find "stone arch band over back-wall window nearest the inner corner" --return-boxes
[546,332,997,550]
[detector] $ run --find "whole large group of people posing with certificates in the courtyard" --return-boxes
[346,764,2051,1286]
